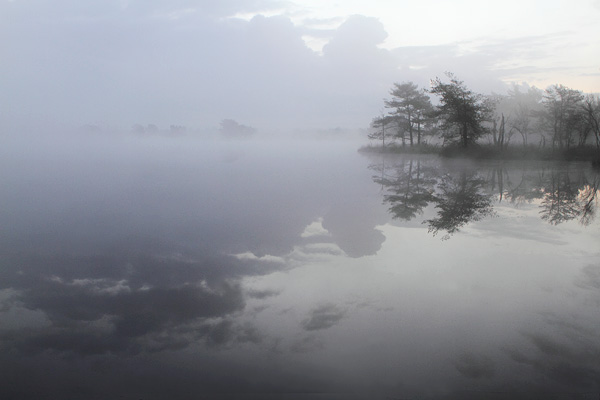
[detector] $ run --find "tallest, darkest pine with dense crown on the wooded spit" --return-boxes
[430,73,491,148]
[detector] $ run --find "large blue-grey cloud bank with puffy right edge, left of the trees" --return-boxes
[0,1,404,131]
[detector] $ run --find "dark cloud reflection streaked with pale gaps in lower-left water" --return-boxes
[0,247,260,356]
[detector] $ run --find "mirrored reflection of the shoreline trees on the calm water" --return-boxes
[369,157,600,239]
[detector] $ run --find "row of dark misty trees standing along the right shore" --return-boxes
[368,73,600,153]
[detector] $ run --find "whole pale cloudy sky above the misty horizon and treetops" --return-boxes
[0,0,600,132]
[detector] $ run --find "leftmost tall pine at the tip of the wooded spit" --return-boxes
[385,82,432,146]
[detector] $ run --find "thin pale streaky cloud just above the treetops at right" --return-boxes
[392,31,595,93]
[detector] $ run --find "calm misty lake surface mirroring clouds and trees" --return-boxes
[0,136,600,399]
